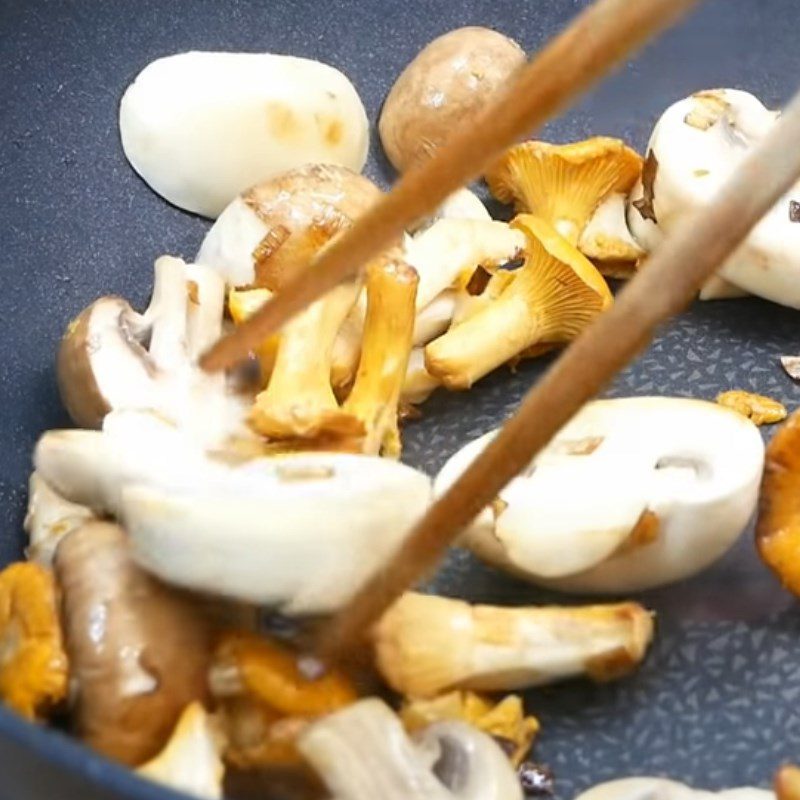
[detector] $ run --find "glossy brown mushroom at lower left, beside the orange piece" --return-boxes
[55,522,210,766]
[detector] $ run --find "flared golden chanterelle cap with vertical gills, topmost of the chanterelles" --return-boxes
[486,136,642,245]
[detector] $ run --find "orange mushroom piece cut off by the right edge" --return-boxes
[756,411,800,597]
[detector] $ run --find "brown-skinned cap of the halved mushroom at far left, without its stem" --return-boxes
[56,297,153,428]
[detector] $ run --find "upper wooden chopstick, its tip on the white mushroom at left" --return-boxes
[200,0,698,371]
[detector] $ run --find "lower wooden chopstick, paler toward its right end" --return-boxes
[320,89,800,660]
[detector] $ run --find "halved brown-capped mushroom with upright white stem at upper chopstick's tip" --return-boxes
[57,256,245,442]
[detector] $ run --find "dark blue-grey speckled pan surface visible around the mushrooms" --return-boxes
[0,0,800,800]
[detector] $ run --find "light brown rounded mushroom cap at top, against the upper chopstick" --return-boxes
[378,27,525,172]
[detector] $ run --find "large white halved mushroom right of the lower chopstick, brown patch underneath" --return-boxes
[435,397,764,594]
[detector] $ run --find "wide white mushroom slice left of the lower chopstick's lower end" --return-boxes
[122,453,431,614]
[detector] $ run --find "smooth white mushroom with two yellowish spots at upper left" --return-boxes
[119,52,369,217]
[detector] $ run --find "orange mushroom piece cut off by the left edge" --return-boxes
[0,561,69,720]
